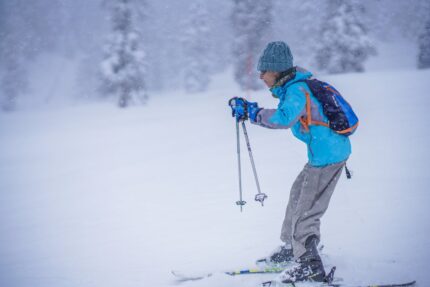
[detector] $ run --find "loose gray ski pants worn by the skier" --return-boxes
[281,162,345,259]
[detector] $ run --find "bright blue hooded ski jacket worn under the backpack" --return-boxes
[255,68,351,167]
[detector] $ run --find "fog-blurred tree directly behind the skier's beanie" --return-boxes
[232,0,272,90]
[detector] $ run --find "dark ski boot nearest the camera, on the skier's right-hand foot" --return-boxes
[280,235,326,283]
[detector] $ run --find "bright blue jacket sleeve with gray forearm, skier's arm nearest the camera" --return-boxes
[254,85,306,129]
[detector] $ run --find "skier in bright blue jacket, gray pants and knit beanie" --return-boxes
[228,42,351,283]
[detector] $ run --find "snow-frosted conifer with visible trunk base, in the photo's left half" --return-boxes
[101,0,147,107]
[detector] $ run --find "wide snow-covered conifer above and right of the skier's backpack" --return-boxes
[316,0,376,73]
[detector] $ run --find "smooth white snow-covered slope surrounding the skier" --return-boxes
[0,65,430,287]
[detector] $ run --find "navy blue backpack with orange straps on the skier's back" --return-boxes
[300,79,359,136]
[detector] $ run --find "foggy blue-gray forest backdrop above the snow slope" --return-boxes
[0,0,430,111]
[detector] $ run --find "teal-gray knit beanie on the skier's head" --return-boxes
[257,41,293,72]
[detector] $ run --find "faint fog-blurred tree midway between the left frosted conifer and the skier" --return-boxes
[183,0,211,92]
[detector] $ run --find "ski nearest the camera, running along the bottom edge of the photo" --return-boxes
[260,280,416,287]
